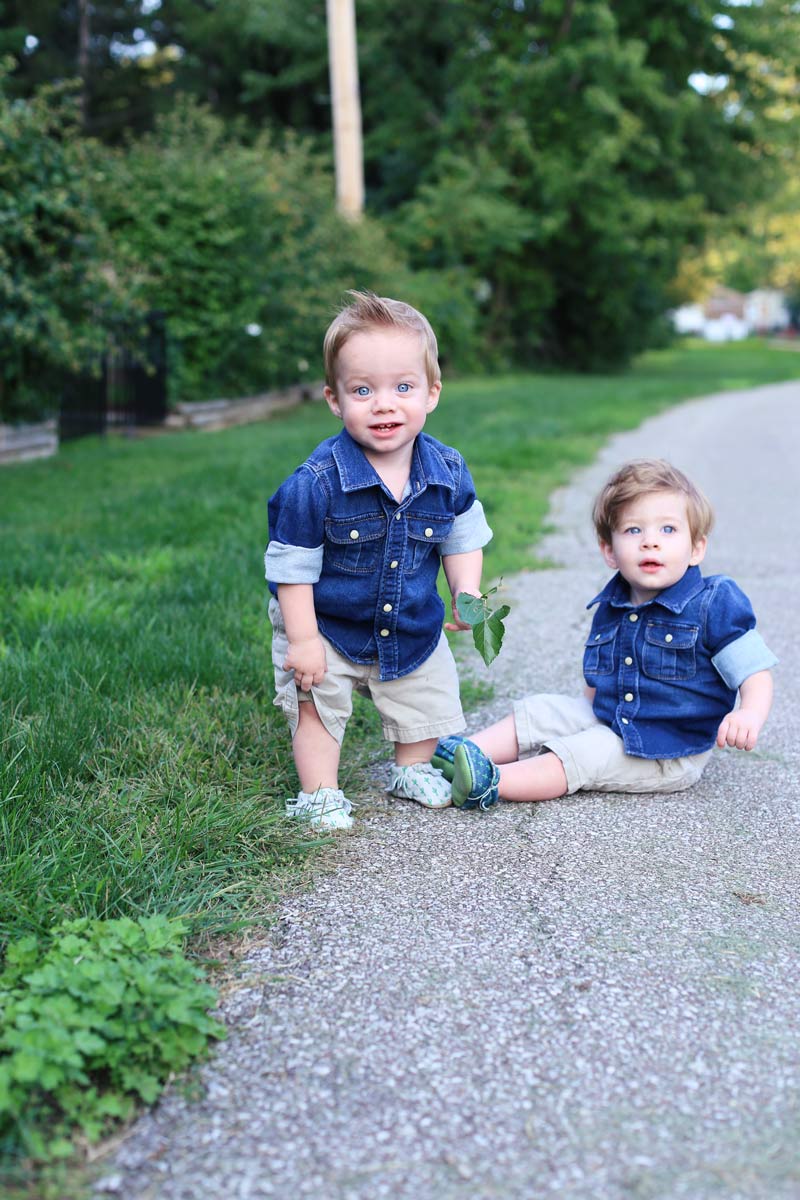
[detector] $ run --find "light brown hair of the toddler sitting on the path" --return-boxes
[591,458,714,545]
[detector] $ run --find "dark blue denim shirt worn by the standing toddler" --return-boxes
[264,430,492,679]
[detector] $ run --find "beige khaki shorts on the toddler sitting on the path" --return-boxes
[513,695,711,792]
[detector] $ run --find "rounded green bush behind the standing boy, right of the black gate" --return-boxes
[96,102,417,400]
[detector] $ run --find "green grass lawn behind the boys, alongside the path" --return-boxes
[0,342,800,943]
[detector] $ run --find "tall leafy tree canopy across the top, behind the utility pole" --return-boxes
[0,0,800,367]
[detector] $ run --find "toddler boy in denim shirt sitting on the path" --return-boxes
[433,460,777,809]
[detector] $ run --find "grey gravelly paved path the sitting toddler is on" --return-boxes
[98,384,800,1200]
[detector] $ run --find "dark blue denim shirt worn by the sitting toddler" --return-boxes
[583,566,777,758]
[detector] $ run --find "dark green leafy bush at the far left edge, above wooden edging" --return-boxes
[0,72,132,420]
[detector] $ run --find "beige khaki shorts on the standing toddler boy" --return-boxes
[270,598,467,745]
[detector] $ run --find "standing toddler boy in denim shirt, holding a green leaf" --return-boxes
[265,292,492,829]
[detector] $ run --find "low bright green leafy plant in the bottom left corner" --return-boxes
[0,917,223,1160]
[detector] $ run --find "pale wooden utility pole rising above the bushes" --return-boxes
[326,0,363,221]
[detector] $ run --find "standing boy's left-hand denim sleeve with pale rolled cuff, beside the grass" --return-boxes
[264,466,327,583]
